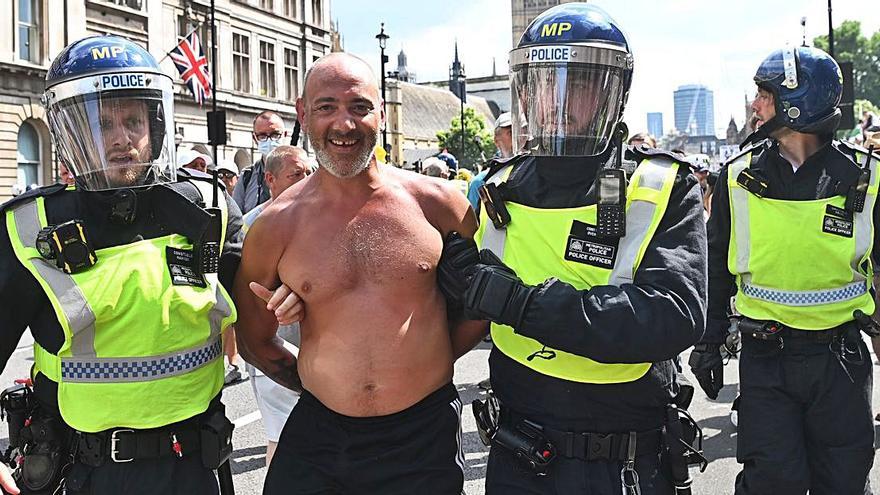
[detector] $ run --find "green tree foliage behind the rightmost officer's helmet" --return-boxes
[813,21,880,105]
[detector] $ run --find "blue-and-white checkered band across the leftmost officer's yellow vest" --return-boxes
[61,337,223,383]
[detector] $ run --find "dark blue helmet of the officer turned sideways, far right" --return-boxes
[754,46,843,136]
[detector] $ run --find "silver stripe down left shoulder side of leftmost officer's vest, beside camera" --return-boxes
[14,201,97,357]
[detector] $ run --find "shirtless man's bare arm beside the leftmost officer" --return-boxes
[234,214,302,391]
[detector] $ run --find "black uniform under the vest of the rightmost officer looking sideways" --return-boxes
[703,140,880,494]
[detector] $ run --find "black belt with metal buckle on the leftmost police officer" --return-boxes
[75,421,202,467]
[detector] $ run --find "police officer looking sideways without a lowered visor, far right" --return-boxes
[690,47,880,494]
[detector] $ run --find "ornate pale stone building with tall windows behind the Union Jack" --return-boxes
[0,0,331,201]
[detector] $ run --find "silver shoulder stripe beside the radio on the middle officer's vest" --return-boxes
[608,160,672,287]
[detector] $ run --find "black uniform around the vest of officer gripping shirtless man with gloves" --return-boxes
[486,150,706,495]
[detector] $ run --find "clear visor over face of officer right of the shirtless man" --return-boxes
[510,63,624,156]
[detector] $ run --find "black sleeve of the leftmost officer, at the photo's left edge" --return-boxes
[0,211,43,370]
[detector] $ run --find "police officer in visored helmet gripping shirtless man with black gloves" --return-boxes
[439,3,706,495]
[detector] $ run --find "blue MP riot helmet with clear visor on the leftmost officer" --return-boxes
[43,36,176,191]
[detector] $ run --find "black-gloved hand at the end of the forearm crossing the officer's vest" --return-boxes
[464,249,537,330]
